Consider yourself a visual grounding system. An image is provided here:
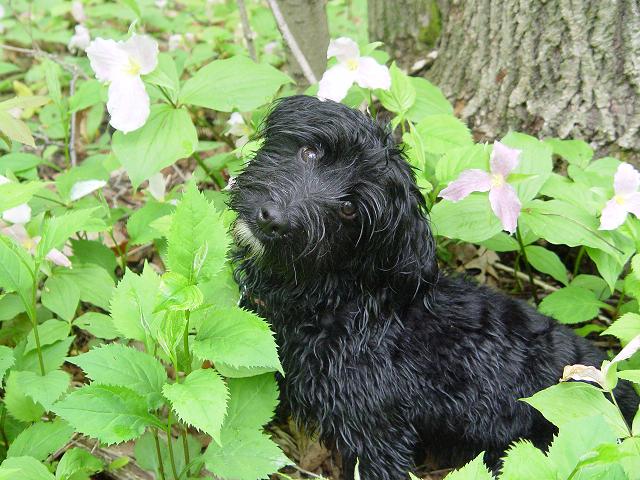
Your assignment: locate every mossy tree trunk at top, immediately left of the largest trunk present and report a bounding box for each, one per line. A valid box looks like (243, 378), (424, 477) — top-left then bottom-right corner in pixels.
(368, 0), (440, 68)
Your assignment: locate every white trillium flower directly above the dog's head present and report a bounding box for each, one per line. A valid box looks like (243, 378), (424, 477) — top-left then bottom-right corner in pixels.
(318, 37), (391, 102)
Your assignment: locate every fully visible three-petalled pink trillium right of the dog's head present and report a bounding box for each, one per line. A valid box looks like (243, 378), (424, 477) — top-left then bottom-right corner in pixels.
(440, 142), (522, 233)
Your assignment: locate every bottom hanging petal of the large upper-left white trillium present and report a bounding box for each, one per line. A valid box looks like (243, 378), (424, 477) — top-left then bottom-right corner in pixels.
(107, 75), (150, 133)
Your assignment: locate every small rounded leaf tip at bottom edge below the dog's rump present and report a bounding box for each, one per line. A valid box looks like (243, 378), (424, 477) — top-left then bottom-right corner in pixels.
(500, 440), (556, 480)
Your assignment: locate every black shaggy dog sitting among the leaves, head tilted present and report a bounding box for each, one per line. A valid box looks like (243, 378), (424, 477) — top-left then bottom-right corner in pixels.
(231, 96), (637, 480)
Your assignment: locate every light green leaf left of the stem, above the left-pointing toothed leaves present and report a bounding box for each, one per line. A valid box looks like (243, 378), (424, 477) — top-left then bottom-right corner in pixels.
(111, 264), (162, 341)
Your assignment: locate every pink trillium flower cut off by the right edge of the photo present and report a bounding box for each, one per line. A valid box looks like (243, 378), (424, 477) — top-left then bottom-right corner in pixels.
(600, 163), (640, 230)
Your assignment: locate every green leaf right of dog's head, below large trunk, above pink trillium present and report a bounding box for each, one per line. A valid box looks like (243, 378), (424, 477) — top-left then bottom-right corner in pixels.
(416, 115), (473, 155)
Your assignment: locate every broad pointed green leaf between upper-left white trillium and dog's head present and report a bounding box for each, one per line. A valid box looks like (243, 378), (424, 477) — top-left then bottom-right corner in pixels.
(180, 56), (291, 112)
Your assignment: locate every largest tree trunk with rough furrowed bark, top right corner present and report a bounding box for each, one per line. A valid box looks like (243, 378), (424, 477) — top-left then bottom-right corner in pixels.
(427, 0), (640, 152)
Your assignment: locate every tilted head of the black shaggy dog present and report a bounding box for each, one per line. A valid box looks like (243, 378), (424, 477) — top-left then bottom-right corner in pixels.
(230, 96), (435, 288)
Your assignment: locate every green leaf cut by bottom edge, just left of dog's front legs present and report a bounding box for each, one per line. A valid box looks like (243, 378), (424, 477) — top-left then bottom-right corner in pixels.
(203, 429), (291, 480)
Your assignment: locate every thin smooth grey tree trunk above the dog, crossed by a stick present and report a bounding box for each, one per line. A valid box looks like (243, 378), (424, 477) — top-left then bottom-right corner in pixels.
(277, 0), (329, 89)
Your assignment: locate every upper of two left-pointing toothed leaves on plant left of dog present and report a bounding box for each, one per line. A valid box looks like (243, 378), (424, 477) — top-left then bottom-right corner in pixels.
(67, 343), (167, 408)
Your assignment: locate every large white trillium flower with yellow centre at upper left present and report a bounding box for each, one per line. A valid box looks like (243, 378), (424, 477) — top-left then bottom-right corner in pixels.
(87, 34), (158, 133)
